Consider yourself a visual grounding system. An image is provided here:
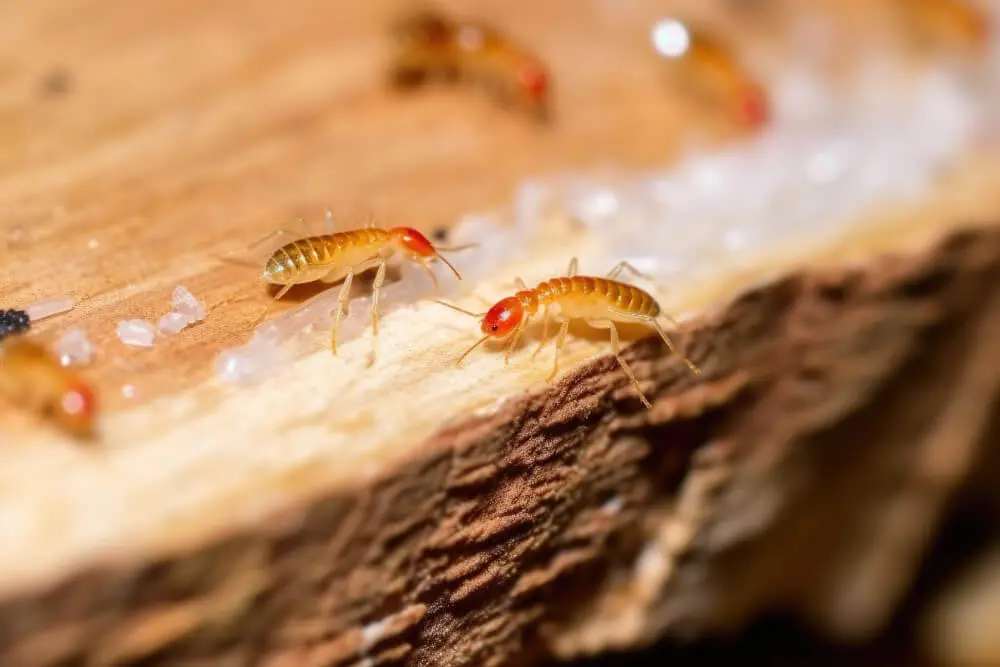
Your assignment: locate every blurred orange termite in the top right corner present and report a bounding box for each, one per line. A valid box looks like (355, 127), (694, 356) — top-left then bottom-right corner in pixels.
(895, 0), (992, 56)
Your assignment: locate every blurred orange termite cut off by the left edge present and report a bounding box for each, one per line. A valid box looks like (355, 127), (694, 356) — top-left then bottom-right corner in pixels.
(0, 335), (97, 439)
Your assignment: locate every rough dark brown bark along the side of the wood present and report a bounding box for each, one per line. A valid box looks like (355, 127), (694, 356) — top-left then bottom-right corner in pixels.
(0, 228), (1000, 667)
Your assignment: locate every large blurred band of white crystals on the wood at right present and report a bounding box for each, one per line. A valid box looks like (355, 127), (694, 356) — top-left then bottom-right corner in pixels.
(568, 59), (984, 278)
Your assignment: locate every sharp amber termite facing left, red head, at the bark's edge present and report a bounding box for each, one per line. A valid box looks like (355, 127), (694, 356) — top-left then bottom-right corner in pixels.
(437, 257), (701, 408)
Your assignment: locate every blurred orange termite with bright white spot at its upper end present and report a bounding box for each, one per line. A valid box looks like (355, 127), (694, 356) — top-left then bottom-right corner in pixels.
(652, 19), (771, 129)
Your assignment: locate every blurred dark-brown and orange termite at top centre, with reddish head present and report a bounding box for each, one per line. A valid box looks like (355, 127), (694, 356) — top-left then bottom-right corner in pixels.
(390, 10), (551, 120)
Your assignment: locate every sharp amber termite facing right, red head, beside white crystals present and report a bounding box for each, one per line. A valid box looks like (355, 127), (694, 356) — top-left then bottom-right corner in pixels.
(245, 214), (475, 354)
